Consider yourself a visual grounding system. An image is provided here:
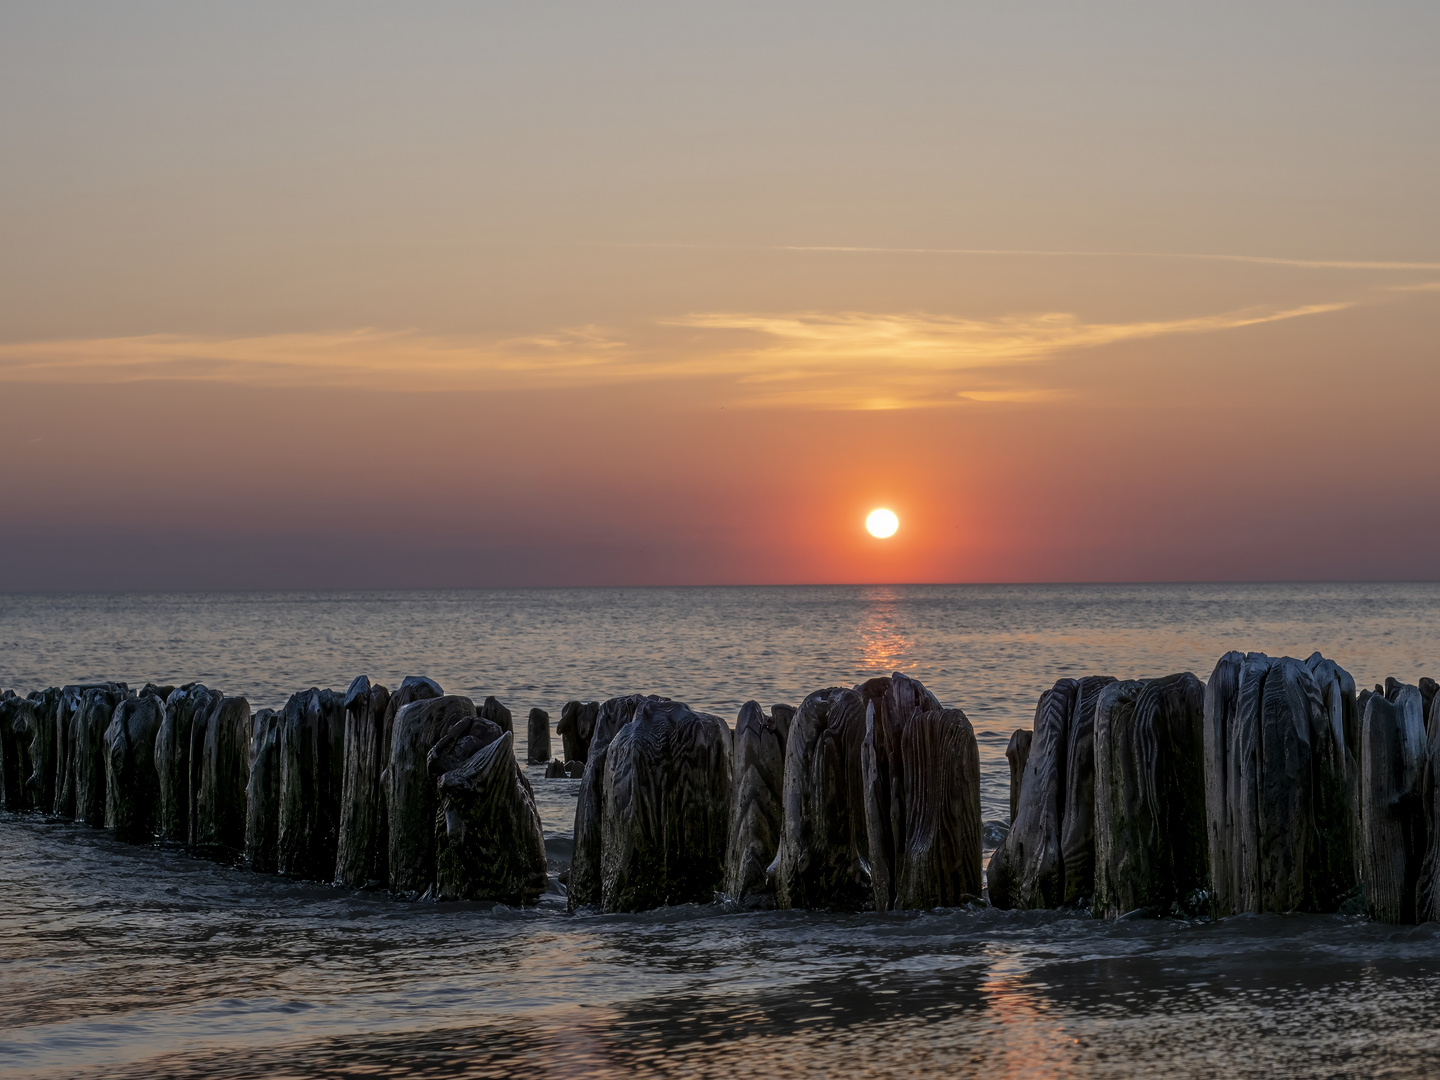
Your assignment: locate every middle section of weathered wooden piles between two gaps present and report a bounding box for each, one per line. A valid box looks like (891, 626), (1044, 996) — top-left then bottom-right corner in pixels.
(555, 674), (984, 912)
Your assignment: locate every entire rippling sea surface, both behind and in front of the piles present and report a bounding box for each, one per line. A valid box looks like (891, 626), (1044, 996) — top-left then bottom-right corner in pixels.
(0, 585), (1440, 1077)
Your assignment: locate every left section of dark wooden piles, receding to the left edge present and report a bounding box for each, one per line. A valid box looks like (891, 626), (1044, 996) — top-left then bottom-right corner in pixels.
(0, 675), (547, 901)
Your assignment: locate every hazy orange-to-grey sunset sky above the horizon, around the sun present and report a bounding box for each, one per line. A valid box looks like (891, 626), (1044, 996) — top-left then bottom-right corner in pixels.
(0, 0), (1440, 590)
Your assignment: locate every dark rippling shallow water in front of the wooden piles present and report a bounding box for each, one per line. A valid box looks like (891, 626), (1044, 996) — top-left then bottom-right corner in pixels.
(11, 815), (1440, 1080)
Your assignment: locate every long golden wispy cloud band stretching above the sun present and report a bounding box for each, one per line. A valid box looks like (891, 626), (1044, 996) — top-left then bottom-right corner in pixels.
(0, 302), (1351, 409)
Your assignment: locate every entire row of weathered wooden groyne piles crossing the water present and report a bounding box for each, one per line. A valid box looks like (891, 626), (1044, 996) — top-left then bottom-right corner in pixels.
(0, 652), (1440, 923)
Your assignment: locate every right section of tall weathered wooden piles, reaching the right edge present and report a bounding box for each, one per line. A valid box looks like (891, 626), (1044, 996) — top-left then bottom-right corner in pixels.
(988, 652), (1440, 923)
